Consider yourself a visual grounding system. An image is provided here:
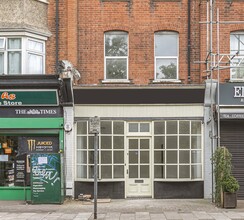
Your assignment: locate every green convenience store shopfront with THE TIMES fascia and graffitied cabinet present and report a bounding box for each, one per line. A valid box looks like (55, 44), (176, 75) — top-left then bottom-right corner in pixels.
(0, 76), (72, 203)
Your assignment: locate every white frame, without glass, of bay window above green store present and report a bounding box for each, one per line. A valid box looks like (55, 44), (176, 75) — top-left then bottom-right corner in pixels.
(0, 32), (47, 75)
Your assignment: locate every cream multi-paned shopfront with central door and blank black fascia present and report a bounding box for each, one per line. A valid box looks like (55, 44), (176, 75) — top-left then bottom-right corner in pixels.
(74, 88), (204, 198)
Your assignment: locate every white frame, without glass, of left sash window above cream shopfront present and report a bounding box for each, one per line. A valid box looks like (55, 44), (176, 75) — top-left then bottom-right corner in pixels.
(103, 31), (129, 83)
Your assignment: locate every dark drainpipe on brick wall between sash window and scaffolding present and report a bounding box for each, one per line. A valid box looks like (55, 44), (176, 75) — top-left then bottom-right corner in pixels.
(187, 0), (191, 82)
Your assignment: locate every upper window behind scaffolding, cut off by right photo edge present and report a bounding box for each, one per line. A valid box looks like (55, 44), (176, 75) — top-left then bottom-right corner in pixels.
(230, 33), (244, 80)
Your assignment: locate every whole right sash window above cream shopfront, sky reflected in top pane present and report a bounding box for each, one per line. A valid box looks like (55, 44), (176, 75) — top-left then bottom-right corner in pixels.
(155, 31), (178, 80)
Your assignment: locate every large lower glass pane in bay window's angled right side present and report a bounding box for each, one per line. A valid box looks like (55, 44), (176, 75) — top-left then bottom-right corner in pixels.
(28, 53), (43, 74)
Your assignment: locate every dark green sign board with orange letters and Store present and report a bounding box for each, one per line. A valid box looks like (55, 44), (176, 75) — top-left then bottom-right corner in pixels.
(0, 89), (59, 107)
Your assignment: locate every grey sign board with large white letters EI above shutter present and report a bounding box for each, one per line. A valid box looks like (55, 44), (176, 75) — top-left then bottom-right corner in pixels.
(219, 83), (244, 106)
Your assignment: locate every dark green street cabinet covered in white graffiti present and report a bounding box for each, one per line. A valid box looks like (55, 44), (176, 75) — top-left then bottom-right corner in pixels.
(31, 153), (61, 204)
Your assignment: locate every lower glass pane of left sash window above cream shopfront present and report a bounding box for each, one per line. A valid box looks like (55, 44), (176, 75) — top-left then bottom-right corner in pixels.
(106, 58), (127, 79)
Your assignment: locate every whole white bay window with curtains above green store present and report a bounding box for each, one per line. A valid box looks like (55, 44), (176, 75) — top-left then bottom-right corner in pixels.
(0, 37), (45, 75)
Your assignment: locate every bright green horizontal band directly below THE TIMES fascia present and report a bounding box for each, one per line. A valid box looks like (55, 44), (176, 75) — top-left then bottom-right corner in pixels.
(0, 118), (64, 129)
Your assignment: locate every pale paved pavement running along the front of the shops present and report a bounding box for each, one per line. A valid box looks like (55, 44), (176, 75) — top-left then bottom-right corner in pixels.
(0, 199), (244, 220)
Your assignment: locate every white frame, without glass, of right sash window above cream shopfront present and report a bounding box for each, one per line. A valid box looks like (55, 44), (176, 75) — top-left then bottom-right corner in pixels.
(154, 31), (180, 82)
